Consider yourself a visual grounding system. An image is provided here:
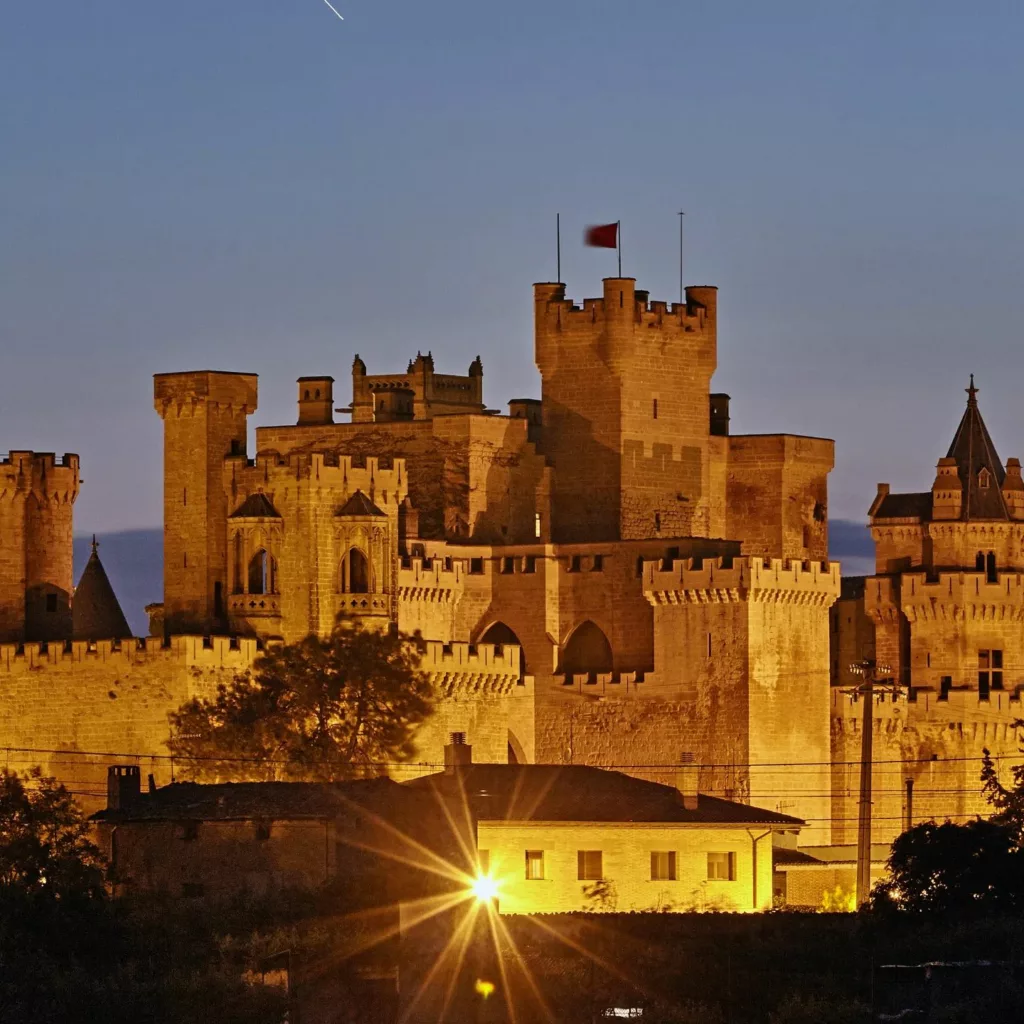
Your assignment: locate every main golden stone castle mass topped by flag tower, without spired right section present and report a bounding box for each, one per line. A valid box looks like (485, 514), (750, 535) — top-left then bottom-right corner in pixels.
(0, 278), (840, 842)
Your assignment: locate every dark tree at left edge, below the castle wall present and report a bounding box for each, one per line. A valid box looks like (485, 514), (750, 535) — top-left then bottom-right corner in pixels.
(0, 768), (103, 899)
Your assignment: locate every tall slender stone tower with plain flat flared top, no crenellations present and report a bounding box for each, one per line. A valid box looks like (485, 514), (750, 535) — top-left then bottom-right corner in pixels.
(154, 371), (257, 634)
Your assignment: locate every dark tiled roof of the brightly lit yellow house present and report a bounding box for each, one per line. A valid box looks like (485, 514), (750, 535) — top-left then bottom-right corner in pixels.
(404, 764), (804, 826)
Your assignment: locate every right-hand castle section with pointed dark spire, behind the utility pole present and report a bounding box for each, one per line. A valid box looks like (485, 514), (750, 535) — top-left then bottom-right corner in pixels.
(830, 377), (1024, 843)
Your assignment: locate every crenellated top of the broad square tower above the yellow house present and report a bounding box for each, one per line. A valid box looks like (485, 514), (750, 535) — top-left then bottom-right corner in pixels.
(643, 557), (840, 606)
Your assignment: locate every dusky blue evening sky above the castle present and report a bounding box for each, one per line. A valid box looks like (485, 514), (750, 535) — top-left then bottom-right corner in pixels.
(0, 6), (1024, 531)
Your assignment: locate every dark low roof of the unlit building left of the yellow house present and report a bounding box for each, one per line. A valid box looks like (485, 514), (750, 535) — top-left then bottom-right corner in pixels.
(92, 778), (410, 821)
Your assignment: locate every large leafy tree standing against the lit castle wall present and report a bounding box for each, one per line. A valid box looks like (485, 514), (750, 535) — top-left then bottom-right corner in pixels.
(168, 624), (431, 781)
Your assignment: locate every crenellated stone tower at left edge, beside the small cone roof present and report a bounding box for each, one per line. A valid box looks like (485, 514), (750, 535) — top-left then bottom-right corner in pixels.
(0, 452), (79, 642)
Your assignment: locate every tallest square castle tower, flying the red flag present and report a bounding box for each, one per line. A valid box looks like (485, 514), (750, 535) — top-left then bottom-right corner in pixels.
(534, 278), (721, 543)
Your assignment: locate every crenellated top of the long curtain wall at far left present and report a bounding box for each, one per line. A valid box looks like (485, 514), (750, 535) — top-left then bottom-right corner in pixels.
(0, 636), (259, 676)
